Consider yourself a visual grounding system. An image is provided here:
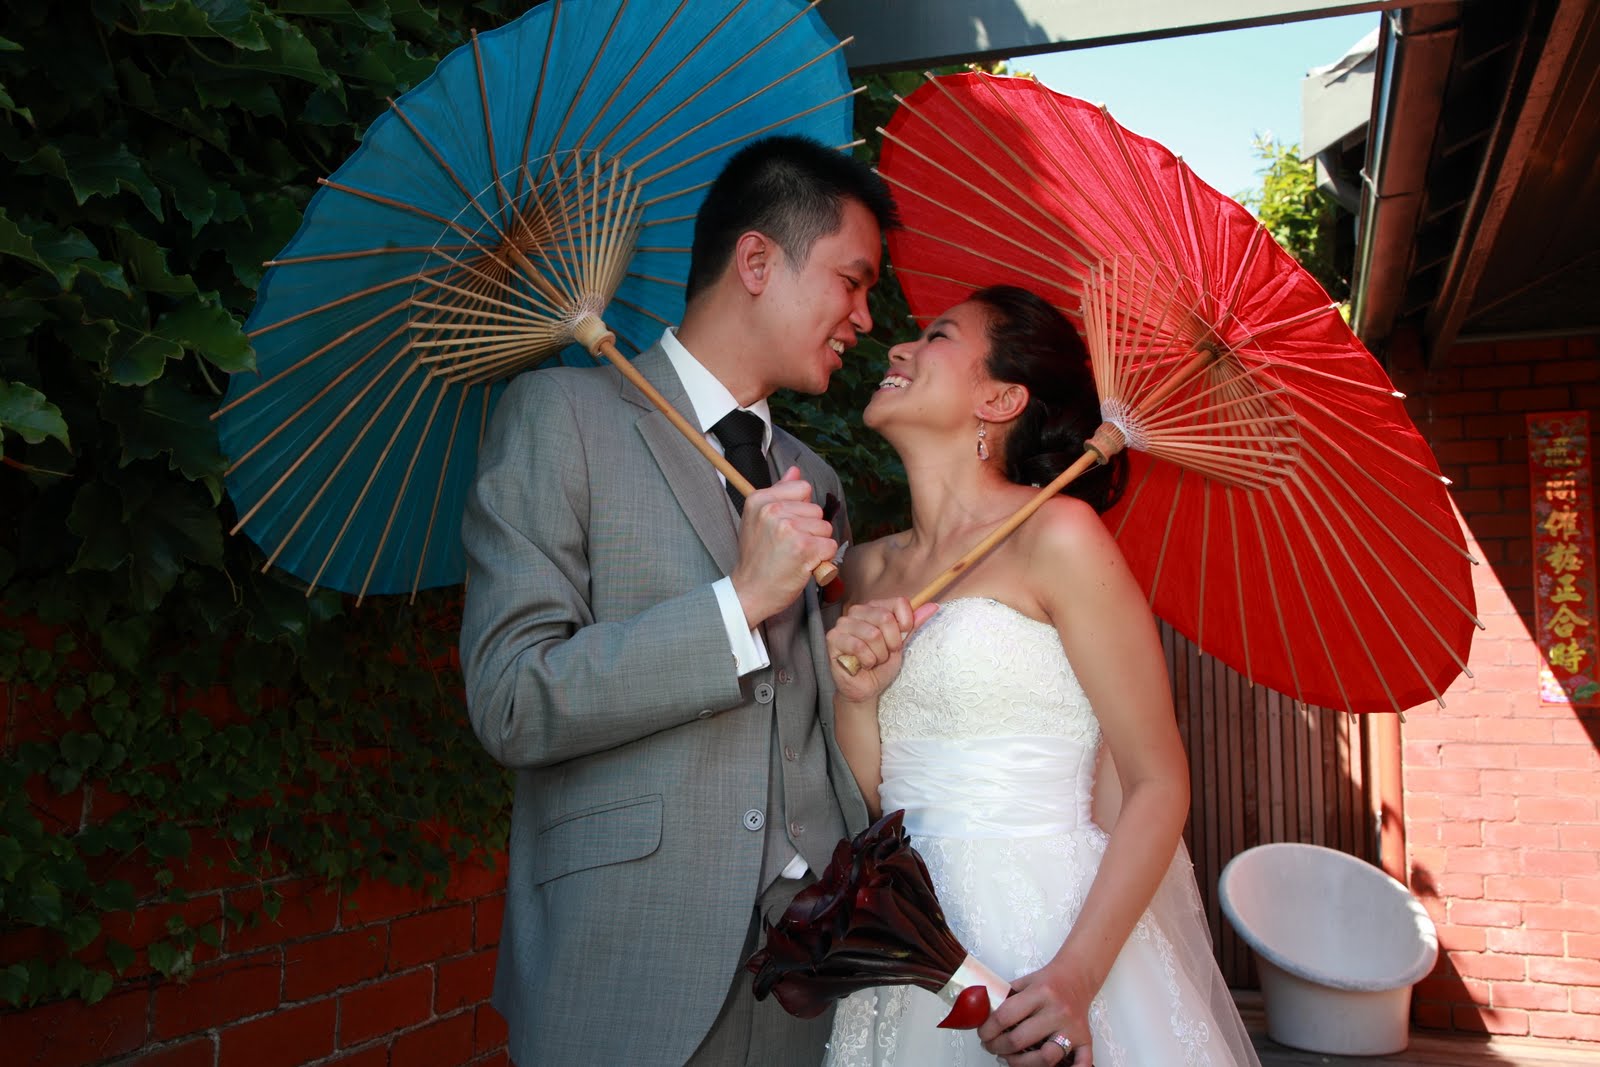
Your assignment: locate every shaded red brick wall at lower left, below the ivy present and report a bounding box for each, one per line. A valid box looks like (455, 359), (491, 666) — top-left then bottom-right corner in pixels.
(0, 864), (506, 1067)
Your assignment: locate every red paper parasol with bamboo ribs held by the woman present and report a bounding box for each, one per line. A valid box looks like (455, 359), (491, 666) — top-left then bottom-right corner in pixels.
(880, 74), (1482, 712)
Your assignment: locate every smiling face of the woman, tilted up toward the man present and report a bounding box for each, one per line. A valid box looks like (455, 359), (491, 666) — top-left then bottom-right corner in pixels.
(862, 301), (989, 432)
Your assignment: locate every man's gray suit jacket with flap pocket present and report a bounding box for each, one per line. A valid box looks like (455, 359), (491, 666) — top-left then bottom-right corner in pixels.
(461, 346), (866, 1067)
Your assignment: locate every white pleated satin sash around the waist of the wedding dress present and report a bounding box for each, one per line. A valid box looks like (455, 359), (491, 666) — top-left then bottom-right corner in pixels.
(878, 736), (1094, 840)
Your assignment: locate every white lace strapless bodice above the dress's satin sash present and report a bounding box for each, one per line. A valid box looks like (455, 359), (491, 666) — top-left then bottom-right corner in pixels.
(878, 597), (1099, 745)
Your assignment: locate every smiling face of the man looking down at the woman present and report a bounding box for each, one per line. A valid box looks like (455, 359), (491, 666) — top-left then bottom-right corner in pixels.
(762, 200), (883, 395)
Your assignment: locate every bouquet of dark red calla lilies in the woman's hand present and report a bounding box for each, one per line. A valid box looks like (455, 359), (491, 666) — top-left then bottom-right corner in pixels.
(746, 811), (1011, 1030)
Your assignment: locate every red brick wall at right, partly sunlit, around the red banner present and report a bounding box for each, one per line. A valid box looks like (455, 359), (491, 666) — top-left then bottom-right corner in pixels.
(1387, 338), (1600, 1041)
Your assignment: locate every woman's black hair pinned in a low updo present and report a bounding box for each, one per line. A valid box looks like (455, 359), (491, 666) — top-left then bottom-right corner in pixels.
(970, 285), (1128, 512)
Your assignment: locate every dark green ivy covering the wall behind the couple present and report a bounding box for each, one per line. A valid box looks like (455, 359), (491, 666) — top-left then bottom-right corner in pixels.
(0, 0), (915, 1006)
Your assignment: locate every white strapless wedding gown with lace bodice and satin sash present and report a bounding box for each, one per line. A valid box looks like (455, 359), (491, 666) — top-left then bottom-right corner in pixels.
(824, 597), (1258, 1067)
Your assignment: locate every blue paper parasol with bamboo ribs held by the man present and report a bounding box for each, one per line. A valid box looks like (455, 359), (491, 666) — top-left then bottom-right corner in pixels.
(216, 0), (851, 595)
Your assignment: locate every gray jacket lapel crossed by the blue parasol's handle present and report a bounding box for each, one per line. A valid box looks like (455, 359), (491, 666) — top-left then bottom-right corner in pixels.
(622, 346), (739, 574)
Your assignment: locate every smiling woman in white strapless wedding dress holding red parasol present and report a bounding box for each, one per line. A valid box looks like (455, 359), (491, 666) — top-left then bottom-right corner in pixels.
(826, 288), (1258, 1067)
